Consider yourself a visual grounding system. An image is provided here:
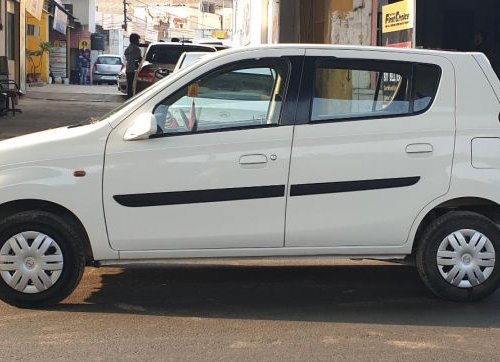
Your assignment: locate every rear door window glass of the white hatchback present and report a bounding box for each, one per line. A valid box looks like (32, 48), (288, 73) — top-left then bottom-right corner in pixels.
(310, 59), (441, 122)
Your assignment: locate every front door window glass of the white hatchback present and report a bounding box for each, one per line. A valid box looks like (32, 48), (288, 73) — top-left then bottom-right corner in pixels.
(154, 59), (289, 135)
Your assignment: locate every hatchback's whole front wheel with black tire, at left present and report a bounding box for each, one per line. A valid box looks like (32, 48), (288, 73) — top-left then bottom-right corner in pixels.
(0, 211), (85, 308)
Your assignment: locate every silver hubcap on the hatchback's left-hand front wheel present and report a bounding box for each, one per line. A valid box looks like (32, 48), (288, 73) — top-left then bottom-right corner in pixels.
(0, 231), (64, 294)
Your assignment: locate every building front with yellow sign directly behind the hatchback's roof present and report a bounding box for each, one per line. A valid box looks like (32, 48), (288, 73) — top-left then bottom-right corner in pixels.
(233, 0), (500, 74)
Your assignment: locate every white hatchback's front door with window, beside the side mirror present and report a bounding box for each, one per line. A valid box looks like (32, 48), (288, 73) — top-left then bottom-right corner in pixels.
(103, 57), (302, 251)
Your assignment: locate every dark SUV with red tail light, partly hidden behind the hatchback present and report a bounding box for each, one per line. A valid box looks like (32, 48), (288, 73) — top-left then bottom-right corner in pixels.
(134, 43), (217, 94)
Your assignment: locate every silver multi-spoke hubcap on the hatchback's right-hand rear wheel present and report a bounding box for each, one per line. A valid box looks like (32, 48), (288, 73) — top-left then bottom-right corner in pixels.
(436, 229), (495, 288)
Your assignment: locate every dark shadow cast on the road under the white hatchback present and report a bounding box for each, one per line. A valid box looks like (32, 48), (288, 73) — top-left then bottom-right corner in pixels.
(55, 265), (500, 327)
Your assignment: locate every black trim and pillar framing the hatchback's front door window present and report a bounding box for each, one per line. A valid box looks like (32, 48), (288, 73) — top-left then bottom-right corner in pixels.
(149, 55), (304, 139)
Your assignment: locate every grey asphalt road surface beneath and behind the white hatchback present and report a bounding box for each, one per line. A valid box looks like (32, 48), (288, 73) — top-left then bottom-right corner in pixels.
(0, 98), (500, 361)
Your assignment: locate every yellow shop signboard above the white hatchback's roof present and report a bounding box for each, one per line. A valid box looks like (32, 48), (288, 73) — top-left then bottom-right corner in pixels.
(382, 0), (415, 48)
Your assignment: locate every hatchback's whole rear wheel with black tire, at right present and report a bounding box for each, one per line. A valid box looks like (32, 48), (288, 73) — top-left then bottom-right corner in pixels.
(416, 211), (500, 302)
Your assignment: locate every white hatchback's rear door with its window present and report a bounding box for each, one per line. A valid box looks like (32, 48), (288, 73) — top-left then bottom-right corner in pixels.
(286, 49), (455, 249)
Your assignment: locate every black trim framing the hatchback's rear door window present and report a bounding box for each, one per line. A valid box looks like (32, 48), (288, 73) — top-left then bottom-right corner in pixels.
(295, 56), (443, 125)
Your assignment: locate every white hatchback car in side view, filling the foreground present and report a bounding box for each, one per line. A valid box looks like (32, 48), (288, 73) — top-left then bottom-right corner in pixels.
(0, 45), (500, 307)
